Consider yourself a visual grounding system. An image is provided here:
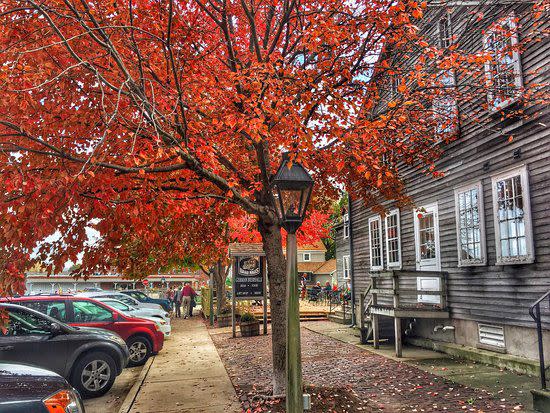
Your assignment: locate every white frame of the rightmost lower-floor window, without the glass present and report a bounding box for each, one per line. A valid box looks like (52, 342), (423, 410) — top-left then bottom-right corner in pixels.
(491, 165), (535, 265)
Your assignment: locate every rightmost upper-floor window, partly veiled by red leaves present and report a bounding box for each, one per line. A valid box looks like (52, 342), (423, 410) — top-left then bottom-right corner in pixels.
(484, 16), (523, 110)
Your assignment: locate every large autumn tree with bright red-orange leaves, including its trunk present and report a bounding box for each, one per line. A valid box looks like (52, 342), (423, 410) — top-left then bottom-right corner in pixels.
(0, 0), (548, 394)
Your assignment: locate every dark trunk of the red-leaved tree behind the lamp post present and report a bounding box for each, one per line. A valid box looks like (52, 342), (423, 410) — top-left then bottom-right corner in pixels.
(258, 218), (286, 395)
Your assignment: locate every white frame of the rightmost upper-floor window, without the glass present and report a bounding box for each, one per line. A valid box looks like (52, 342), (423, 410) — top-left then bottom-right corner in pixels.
(483, 13), (523, 112)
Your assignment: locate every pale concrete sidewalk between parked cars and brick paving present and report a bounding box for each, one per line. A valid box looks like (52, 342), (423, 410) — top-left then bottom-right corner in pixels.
(120, 317), (241, 413)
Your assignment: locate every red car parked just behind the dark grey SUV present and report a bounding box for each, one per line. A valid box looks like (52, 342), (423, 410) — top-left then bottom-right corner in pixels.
(1, 295), (164, 366)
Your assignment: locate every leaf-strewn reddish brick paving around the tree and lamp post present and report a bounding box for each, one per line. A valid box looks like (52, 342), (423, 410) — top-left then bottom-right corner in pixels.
(211, 329), (523, 413)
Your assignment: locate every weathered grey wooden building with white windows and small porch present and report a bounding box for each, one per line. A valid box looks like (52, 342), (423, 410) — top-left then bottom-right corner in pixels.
(336, 2), (550, 359)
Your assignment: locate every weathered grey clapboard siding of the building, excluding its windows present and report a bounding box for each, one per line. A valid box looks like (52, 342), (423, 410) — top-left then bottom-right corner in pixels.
(344, 2), (550, 329)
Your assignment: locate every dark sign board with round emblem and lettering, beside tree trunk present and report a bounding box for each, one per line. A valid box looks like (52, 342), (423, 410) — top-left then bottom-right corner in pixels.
(233, 256), (264, 300)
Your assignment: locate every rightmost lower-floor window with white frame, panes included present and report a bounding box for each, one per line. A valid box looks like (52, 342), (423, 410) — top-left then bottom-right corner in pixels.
(492, 166), (535, 264)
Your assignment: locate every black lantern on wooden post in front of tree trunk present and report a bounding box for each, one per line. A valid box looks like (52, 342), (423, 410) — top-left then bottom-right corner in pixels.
(273, 153), (313, 413)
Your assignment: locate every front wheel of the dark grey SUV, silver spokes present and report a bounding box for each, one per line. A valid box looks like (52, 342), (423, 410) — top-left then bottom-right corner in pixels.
(71, 352), (117, 399)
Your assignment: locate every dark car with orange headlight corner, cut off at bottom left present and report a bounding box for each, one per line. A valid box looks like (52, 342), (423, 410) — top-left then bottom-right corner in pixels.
(0, 362), (84, 413)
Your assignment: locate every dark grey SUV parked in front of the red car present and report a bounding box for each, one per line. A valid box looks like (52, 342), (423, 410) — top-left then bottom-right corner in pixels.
(0, 303), (128, 397)
